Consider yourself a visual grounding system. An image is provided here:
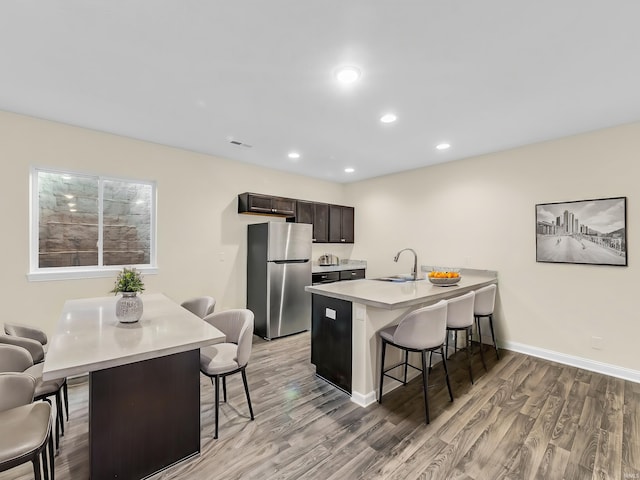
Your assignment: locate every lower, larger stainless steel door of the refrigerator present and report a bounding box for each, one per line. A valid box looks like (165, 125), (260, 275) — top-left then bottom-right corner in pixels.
(264, 261), (311, 338)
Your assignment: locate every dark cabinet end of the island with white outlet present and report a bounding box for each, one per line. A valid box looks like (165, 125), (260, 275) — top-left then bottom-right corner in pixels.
(311, 295), (352, 395)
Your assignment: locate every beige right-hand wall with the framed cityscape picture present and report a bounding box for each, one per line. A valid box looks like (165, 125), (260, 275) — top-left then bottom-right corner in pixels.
(348, 123), (640, 378)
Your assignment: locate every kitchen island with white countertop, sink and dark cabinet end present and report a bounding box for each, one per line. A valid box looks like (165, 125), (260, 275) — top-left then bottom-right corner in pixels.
(305, 267), (497, 407)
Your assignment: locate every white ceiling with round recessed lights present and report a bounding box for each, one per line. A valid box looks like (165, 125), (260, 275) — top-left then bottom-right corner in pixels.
(0, 0), (640, 182)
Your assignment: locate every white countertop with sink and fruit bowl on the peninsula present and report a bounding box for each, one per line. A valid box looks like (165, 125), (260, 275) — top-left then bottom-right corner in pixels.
(305, 270), (498, 310)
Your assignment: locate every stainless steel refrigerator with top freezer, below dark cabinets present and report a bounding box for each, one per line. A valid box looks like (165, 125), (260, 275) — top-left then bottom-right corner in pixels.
(247, 222), (312, 339)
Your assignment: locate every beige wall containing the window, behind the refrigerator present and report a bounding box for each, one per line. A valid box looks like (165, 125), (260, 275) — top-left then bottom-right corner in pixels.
(0, 112), (351, 333)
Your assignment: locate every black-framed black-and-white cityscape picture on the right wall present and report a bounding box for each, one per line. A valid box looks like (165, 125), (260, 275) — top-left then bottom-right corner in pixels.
(536, 197), (627, 266)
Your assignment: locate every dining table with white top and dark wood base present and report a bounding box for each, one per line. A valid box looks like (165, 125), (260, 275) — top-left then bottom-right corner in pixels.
(42, 294), (225, 480)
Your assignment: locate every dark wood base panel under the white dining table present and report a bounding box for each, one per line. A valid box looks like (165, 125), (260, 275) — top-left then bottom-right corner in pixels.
(89, 350), (200, 480)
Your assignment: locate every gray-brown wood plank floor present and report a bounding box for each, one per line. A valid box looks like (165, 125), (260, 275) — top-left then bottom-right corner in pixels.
(0, 333), (640, 480)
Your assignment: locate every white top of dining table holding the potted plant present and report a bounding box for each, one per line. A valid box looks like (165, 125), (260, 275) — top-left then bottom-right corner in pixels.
(42, 293), (225, 380)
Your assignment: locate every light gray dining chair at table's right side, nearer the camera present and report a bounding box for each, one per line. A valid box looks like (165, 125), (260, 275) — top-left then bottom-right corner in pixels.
(200, 309), (254, 438)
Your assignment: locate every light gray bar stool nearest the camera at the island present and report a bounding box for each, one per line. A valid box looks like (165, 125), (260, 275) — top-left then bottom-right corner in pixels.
(378, 300), (453, 424)
